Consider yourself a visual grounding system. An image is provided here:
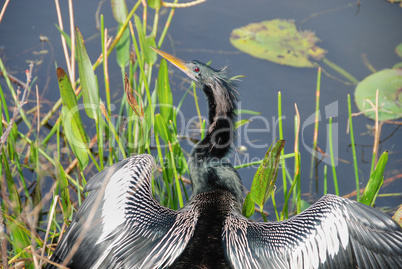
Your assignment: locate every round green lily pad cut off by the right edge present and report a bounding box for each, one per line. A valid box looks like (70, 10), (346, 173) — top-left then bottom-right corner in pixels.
(355, 69), (402, 121)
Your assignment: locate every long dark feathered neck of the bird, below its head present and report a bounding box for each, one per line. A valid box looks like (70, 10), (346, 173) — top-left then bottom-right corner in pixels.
(189, 77), (243, 203)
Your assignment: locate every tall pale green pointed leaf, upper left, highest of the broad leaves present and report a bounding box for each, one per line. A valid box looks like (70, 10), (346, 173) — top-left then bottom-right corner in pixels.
(75, 27), (99, 121)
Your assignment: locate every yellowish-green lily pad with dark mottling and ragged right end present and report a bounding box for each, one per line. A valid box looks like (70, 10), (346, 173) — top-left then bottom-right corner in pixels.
(230, 19), (326, 67)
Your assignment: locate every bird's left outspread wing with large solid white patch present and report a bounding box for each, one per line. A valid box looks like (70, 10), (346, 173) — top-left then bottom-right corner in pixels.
(46, 154), (198, 268)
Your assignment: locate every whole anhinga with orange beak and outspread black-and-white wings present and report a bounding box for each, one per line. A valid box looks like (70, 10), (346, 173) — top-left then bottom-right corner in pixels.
(47, 49), (402, 269)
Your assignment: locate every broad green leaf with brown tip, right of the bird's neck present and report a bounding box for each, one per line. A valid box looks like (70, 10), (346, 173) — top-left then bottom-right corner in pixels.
(250, 140), (285, 208)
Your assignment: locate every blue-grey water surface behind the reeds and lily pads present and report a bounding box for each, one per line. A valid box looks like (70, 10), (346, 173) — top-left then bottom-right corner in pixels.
(0, 0), (402, 215)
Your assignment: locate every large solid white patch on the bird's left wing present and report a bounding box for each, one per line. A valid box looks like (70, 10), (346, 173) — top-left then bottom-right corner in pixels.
(96, 164), (130, 244)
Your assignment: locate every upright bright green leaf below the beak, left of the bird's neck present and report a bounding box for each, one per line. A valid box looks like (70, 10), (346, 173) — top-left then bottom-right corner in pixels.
(157, 59), (173, 123)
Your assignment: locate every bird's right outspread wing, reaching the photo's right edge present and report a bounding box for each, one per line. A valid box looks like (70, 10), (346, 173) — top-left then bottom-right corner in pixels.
(222, 195), (402, 269)
